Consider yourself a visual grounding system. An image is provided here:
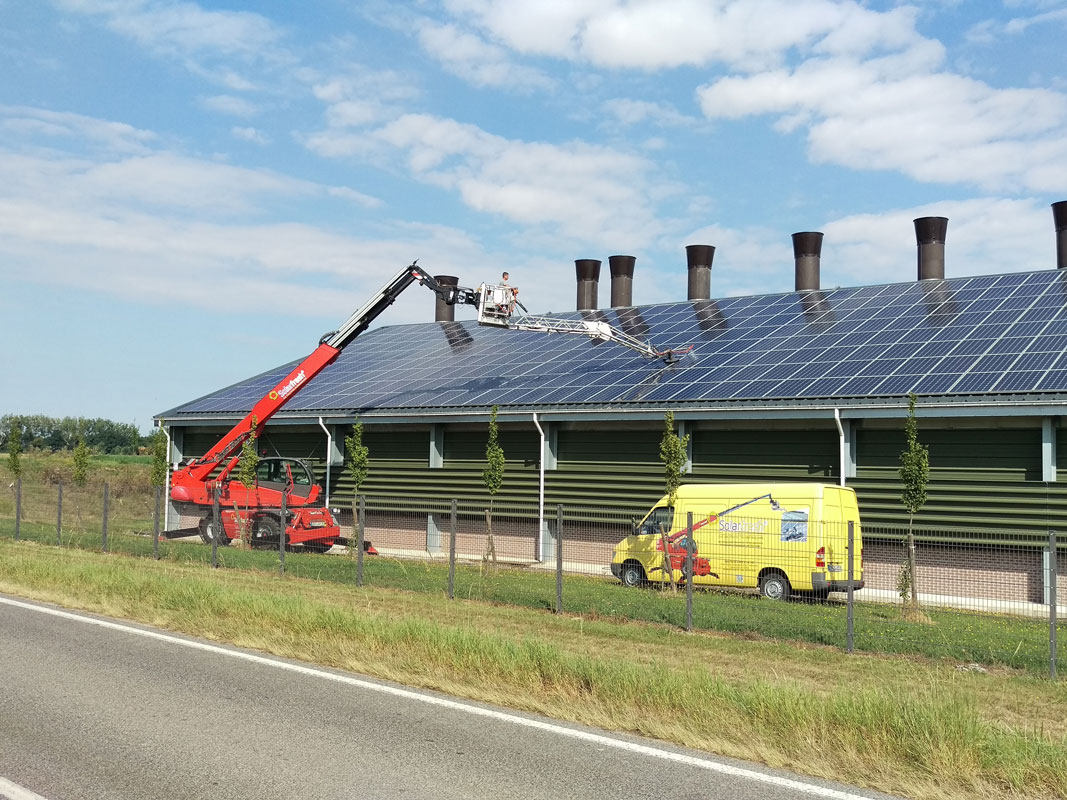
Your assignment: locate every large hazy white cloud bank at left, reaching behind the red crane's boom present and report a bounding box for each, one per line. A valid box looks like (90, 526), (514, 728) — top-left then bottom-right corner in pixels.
(0, 109), (550, 324)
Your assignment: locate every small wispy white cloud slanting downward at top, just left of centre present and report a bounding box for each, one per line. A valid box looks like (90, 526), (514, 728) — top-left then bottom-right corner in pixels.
(416, 19), (553, 91)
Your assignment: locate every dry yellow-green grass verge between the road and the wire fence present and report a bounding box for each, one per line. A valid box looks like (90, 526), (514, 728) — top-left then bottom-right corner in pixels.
(0, 539), (1067, 799)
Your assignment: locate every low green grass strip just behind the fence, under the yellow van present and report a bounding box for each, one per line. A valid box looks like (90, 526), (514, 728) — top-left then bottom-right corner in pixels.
(0, 518), (1067, 675)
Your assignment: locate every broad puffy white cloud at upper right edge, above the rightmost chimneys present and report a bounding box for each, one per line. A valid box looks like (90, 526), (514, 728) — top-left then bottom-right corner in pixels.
(698, 54), (1067, 192)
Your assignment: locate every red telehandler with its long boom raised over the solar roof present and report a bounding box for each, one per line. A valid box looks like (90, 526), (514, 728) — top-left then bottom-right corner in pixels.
(168, 263), (480, 551)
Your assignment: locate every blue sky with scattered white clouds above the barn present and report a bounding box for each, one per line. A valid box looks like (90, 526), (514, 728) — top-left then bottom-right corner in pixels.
(0, 0), (1067, 432)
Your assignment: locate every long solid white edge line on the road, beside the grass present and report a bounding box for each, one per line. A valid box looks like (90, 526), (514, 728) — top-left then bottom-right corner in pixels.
(0, 597), (870, 800)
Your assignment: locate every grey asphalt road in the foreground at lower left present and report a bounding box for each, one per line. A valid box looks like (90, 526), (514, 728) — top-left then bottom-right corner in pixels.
(0, 596), (900, 800)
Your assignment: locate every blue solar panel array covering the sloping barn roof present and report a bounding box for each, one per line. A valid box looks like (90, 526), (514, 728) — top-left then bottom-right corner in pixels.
(163, 271), (1067, 416)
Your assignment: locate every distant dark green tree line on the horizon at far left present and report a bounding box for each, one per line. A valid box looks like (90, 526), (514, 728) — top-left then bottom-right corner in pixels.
(0, 414), (152, 455)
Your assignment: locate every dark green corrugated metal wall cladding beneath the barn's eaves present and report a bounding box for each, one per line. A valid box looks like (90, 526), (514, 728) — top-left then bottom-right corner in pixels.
(177, 426), (1067, 539)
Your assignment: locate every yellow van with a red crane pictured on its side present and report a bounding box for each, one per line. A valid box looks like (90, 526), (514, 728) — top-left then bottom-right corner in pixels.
(611, 483), (863, 599)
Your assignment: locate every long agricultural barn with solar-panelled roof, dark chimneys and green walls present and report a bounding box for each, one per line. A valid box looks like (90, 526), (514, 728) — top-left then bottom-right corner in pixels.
(157, 202), (1067, 602)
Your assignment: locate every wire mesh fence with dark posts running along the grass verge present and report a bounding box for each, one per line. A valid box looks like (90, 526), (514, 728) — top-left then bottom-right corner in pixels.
(0, 480), (1067, 676)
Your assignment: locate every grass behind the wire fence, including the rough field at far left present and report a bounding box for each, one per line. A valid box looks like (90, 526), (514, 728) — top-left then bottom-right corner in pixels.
(0, 454), (1067, 675)
